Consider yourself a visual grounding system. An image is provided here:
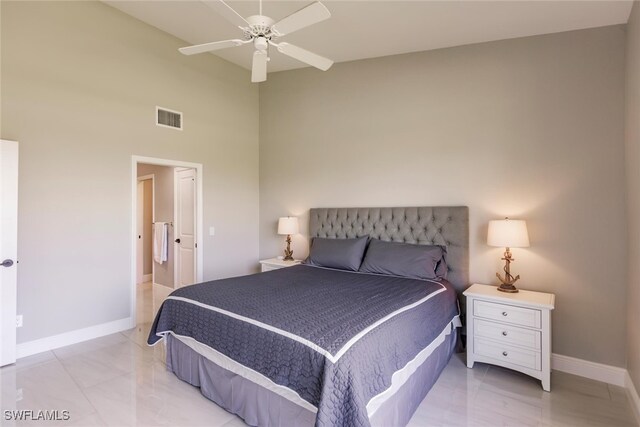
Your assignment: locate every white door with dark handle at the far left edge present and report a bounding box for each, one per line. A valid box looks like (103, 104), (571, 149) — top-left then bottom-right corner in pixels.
(0, 141), (18, 366)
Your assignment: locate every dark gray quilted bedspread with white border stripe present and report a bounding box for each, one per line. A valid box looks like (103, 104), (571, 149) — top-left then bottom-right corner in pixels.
(148, 265), (458, 426)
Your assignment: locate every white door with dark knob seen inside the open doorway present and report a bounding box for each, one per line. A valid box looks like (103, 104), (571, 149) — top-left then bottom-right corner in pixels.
(174, 169), (197, 288)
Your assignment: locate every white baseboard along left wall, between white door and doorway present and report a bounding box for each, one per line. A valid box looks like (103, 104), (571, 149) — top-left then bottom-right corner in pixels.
(16, 317), (135, 359)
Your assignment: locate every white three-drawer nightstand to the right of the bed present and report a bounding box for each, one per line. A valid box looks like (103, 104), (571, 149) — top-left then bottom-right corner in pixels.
(464, 284), (555, 391)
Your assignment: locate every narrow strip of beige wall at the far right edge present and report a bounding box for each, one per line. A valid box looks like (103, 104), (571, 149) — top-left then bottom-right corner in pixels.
(626, 1), (640, 390)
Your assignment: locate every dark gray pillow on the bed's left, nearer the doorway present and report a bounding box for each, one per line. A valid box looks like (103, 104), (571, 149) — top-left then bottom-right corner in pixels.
(306, 236), (369, 271)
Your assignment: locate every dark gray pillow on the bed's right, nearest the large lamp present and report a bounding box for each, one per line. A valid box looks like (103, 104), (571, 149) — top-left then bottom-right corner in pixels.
(360, 239), (447, 279)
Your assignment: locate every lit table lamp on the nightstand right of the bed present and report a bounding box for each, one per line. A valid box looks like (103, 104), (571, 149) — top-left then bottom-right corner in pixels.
(487, 218), (529, 293)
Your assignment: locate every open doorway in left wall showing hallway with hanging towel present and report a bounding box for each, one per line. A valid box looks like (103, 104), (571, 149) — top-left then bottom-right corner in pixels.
(131, 156), (203, 334)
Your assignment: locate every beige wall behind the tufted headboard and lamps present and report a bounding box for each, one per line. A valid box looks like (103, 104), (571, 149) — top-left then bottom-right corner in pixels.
(260, 26), (627, 366)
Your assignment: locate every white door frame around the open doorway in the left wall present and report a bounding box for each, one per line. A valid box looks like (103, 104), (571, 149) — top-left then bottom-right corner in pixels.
(129, 155), (204, 328)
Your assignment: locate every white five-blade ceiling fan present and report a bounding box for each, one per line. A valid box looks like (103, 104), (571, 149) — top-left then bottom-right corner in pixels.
(178, 0), (333, 83)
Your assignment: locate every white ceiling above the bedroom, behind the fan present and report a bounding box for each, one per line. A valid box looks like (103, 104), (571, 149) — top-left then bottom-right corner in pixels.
(105, 0), (633, 72)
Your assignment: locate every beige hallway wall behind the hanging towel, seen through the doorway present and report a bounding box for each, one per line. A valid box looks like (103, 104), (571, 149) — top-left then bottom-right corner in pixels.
(138, 163), (175, 288)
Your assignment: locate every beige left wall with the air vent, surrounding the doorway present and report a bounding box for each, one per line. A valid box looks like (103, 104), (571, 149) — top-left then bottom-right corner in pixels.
(0, 1), (259, 343)
